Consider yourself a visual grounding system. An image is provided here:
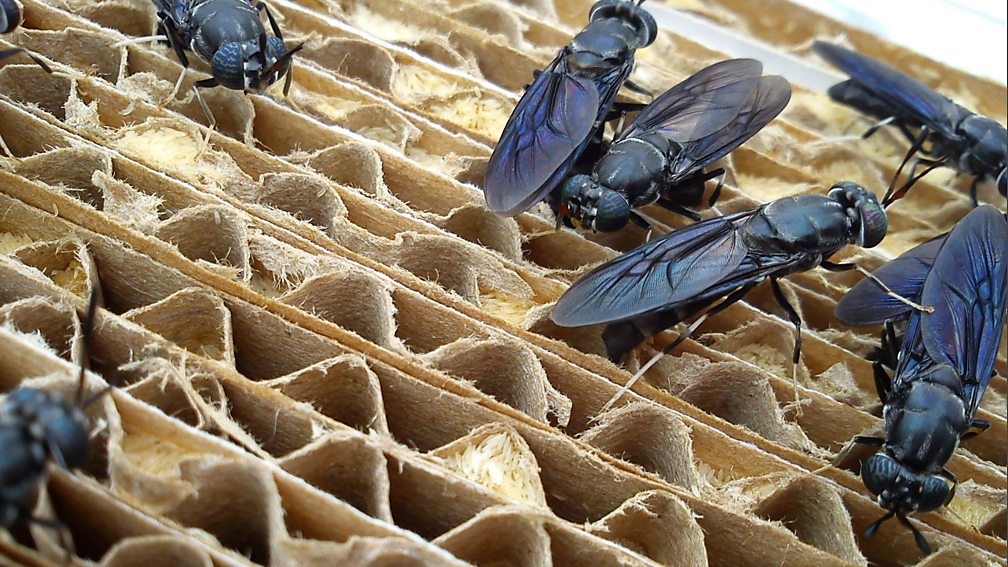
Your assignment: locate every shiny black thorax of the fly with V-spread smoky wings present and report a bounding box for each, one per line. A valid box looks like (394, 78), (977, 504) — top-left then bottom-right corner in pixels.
(592, 138), (668, 207)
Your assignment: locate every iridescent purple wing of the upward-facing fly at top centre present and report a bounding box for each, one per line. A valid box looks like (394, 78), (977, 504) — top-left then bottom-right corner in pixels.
(483, 58), (596, 216)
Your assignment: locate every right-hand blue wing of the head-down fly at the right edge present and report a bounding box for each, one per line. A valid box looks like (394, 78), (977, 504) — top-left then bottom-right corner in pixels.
(920, 205), (1008, 418)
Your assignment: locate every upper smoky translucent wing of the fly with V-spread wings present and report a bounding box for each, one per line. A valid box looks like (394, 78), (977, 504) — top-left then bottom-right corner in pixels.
(614, 60), (763, 143)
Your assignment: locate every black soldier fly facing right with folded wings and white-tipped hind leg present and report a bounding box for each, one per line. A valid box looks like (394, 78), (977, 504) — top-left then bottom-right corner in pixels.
(550, 182), (888, 407)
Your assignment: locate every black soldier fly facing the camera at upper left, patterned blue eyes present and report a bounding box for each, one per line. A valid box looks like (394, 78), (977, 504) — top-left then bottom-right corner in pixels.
(153, 0), (302, 125)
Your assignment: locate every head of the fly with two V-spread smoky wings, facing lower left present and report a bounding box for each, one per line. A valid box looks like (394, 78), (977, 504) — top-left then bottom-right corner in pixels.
(560, 175), (630, 232)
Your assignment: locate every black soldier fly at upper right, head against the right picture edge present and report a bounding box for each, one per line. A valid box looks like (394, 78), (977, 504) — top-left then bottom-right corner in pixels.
(812, 41), (1008, 206)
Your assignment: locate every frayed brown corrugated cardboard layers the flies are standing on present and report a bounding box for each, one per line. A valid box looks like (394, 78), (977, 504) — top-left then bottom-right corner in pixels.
(0, 0), (1008, 565)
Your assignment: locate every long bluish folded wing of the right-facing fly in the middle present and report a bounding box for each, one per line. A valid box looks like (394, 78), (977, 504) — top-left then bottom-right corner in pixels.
(550, 211), (753, 327)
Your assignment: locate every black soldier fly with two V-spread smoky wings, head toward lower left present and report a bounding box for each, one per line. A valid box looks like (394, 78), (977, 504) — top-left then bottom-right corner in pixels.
(558, 60), (791, 231)
